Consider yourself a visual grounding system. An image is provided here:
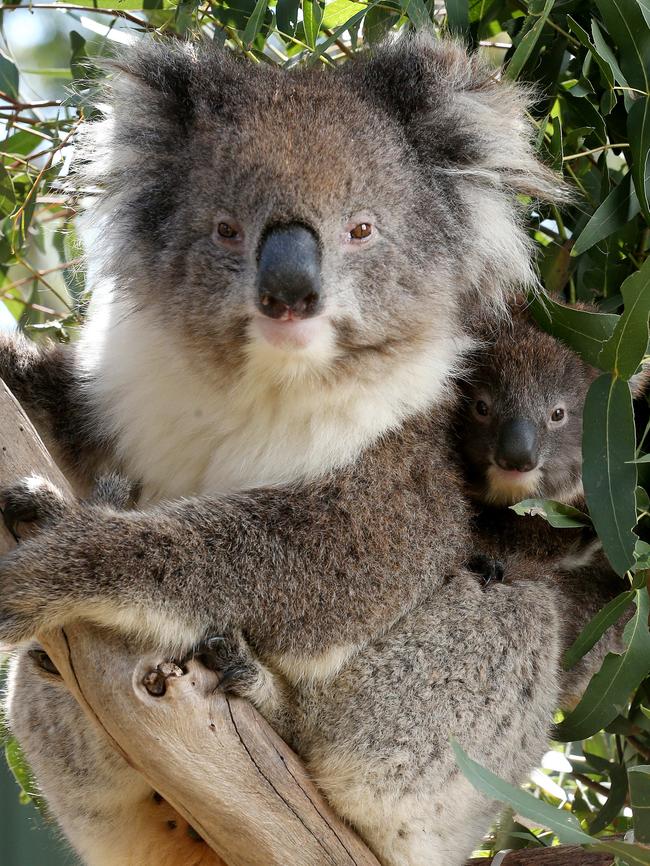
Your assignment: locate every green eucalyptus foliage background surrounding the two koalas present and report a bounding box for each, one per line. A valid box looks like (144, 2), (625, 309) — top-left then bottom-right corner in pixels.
(0, 0), (650, 866)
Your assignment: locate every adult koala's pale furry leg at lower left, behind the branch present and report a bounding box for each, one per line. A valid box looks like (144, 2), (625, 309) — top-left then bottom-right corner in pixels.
(7, 649), (223, 866)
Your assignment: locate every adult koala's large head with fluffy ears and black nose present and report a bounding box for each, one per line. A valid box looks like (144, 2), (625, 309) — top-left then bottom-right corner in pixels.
(77, 36), (559, 390)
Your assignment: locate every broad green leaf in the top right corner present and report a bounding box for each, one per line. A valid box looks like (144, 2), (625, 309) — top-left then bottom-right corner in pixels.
(596, 0), (650, 93)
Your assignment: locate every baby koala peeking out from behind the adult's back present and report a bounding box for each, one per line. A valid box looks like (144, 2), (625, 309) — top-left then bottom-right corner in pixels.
(451, 297), (624, 707)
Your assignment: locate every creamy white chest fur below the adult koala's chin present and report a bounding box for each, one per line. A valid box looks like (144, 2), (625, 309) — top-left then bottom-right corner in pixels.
(79, 288), (458, 502)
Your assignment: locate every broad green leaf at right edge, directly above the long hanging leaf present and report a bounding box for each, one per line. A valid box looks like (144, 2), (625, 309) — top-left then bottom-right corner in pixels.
(598, 259), (650, 381)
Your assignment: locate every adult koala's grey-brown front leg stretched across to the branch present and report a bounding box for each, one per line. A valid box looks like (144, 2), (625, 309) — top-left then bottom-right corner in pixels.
(0, 466), (426, 655)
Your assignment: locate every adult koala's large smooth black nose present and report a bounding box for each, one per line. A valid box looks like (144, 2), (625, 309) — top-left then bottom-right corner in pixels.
(257, 223), (322, 319)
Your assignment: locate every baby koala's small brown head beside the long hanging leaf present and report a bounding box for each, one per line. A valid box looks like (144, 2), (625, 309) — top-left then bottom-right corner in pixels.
(456, 306), (597, 506)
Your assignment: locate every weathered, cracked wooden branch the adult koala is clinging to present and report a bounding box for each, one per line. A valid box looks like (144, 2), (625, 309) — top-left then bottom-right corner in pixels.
(0, 381), (613, 866)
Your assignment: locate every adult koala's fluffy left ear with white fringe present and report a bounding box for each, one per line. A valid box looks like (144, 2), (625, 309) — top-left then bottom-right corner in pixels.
(75, 40), (234, 248)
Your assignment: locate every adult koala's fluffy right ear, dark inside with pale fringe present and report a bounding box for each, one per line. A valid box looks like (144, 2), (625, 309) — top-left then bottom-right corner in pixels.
(350, 33), (564, 200)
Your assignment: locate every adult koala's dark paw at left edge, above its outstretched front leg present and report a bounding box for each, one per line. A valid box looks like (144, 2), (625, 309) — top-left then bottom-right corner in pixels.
(0, 475), (70, 540)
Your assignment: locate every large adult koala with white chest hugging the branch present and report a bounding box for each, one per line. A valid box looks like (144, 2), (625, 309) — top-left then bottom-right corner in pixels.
(0, 36), (561, 866)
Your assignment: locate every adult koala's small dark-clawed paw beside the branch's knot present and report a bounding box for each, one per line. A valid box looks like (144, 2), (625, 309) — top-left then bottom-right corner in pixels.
(192, 631), (273, 705)
